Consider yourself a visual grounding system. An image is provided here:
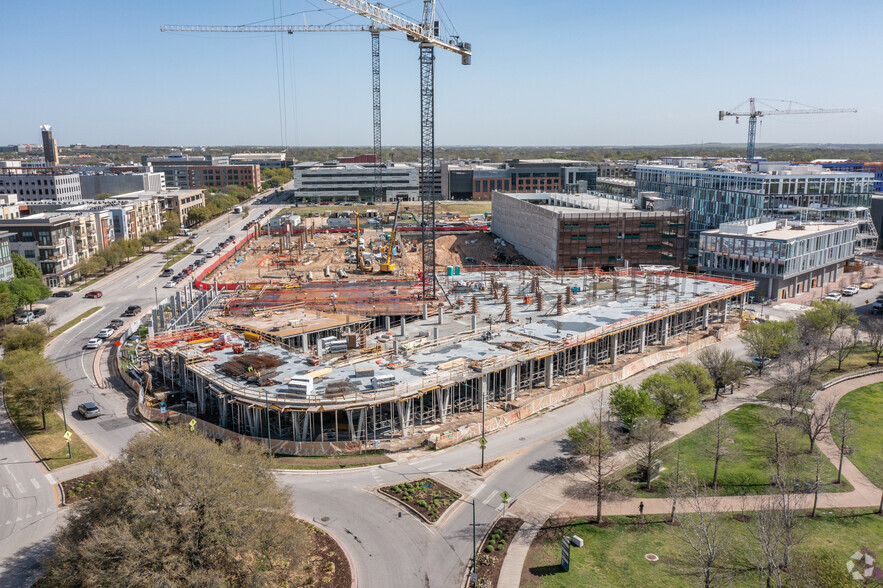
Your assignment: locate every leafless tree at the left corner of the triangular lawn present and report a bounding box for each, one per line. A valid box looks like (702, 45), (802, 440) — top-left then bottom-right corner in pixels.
(567, 420), (618, 525)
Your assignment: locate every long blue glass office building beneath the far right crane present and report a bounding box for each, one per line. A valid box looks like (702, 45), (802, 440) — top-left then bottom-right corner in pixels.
(635, 158), (874, 232)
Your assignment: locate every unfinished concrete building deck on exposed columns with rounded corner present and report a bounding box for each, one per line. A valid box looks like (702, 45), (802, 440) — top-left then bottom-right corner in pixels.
(142, 266), (754, 448)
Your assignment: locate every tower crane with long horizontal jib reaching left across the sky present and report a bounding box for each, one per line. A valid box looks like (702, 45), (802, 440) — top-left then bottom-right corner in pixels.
(159, 24), (395, 204)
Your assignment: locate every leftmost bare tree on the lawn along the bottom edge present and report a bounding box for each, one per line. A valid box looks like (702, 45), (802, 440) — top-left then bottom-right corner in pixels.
(677, 479), (731, 588)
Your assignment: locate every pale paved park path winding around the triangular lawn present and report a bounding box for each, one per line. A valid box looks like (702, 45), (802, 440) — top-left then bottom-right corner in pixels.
(498, 374), (883, 586)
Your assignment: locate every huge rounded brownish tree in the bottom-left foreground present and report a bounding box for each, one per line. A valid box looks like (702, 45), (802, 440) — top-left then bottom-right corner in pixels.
(43, 427), (310, 588)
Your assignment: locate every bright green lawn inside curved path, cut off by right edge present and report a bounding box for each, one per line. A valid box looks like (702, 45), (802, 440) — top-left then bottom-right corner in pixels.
(837, 382), (883, 487)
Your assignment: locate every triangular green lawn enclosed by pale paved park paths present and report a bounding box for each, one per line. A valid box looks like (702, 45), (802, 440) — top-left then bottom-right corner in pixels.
(635, 404), (852, 497)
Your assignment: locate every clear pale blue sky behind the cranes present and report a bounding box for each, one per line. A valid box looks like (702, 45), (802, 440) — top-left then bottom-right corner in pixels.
(0, 0), (883, 146)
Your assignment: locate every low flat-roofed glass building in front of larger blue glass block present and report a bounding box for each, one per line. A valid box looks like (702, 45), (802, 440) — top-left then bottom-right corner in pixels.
(699, 218), (858, 300)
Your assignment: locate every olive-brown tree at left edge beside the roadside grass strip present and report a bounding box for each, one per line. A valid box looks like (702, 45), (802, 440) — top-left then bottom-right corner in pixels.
(0, 349), (70, 429)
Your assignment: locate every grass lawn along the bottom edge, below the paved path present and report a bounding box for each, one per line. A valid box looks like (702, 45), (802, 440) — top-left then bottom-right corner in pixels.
(521, 511), (883, 588)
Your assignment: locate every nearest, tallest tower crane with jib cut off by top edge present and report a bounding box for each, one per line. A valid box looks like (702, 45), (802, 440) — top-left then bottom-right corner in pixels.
(325, 0), (472, 299)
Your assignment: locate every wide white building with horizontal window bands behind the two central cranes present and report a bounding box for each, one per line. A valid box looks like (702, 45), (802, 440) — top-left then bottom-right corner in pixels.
(294, 161), (420, 202)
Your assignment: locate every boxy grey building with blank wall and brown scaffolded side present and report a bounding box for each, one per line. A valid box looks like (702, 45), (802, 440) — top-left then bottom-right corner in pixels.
(491, 192), (689, 270)
